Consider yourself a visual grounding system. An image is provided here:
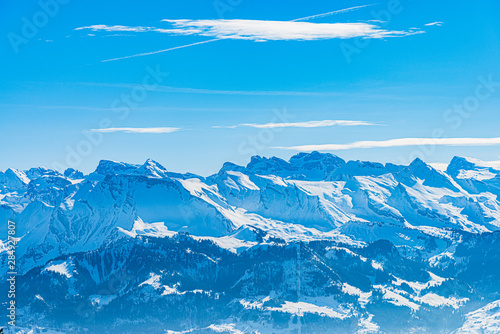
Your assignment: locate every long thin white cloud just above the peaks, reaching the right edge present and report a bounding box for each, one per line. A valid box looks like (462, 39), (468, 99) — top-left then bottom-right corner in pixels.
(273, 137), (500, 151)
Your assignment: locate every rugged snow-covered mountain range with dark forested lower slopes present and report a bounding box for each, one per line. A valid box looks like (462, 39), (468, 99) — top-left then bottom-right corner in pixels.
(0, 152), (500, 333)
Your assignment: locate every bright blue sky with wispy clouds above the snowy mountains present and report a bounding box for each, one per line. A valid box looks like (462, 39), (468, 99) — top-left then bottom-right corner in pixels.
(0, 0), (500, 175)
